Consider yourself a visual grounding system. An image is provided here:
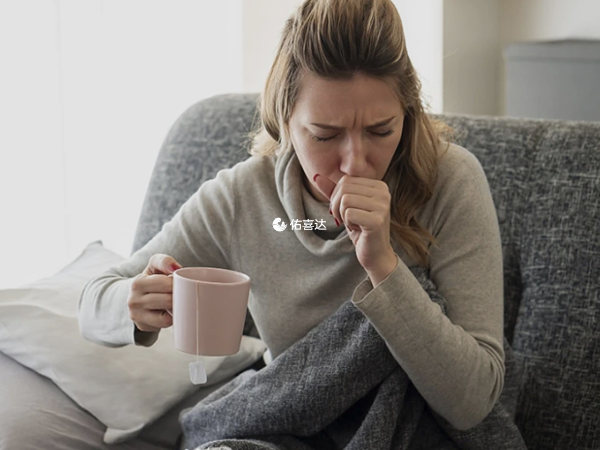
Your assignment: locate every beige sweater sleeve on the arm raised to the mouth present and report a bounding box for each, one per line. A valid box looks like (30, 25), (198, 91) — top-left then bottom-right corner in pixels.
(352, 155), (505, 430)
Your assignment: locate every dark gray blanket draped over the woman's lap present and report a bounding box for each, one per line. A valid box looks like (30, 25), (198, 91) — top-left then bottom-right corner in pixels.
(179, 267), (526, 450)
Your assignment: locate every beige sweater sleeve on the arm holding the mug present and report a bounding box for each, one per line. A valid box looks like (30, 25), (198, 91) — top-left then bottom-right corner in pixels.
(78, 166), (236, 347)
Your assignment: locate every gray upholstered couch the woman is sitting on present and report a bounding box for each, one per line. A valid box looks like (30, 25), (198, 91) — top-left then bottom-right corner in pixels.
(0, 94), (600, 450)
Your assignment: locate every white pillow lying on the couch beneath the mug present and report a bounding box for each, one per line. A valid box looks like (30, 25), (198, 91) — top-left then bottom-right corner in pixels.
(0, 241), (266, 444)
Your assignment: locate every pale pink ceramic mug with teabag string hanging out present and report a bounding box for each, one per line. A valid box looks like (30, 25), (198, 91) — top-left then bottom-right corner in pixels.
(172, 267), (250, 356)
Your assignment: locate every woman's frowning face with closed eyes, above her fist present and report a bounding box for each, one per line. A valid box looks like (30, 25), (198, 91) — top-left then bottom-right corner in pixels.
(289, 72), (404, 202)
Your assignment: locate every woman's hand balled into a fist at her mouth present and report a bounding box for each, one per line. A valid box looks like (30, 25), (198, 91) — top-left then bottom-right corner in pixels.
(314, 174), (397, 273)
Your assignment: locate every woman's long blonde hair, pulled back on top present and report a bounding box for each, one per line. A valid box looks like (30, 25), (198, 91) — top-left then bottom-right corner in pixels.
(248, 0), (453, 267)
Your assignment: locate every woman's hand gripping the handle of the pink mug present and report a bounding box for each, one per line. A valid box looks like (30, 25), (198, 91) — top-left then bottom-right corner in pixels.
(127, 253), (181, 331)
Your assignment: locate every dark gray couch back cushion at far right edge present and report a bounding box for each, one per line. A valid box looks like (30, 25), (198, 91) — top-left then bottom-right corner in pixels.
(513, 123), (600, 449)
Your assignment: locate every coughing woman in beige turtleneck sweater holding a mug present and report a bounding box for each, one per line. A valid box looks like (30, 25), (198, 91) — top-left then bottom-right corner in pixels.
(80, 0), (505, 438)
